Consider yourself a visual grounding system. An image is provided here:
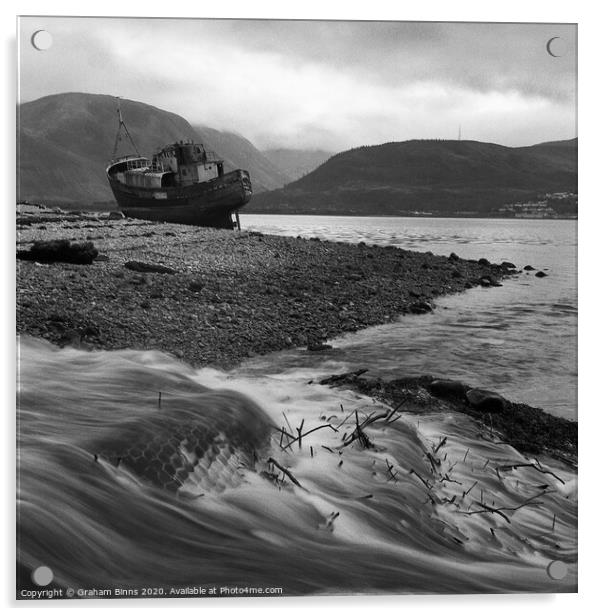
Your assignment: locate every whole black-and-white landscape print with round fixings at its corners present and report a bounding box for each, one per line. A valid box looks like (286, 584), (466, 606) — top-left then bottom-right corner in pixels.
(15, 13), (579, 609)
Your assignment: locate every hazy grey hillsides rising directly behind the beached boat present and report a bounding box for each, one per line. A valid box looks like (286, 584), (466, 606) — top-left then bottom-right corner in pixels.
(17, 93), (287, 207)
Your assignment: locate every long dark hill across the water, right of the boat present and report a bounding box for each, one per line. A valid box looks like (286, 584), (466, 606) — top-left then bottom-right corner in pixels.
(248, 139), (577, 215)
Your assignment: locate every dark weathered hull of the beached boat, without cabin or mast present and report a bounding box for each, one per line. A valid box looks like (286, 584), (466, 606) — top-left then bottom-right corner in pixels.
(107, 170), (253, 229)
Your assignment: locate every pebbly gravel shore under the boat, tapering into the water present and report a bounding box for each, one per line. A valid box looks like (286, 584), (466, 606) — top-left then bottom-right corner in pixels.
(17, 212), (513, 368)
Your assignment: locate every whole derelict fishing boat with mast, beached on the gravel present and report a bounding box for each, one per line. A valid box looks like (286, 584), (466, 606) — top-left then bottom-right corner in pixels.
(106, 103), (253, 229)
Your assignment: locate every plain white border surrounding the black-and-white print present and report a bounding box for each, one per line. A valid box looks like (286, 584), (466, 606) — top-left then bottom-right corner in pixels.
(0, 0), (602, 616)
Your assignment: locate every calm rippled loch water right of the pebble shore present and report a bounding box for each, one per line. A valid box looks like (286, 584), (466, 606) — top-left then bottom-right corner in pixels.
(242, 215), (577, 419)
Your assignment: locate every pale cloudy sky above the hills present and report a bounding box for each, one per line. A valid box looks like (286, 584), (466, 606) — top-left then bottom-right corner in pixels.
(18, 17), (577, 151)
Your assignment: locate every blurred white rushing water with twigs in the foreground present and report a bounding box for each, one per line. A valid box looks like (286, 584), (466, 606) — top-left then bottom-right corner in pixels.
(17, 337), (577, 595)
